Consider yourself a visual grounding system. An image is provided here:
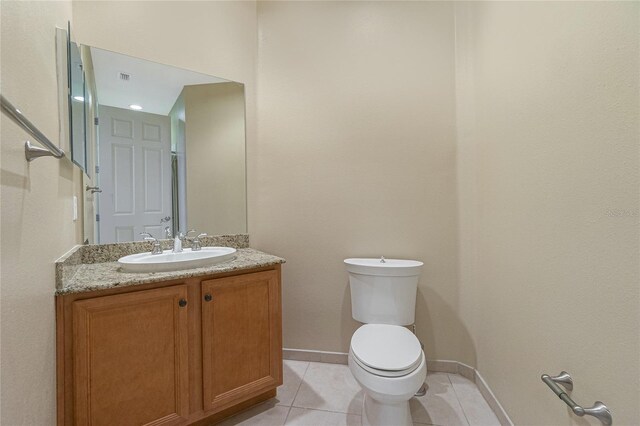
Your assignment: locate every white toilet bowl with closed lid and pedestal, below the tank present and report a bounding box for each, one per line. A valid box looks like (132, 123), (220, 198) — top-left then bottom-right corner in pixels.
(349, 324), (427, 426)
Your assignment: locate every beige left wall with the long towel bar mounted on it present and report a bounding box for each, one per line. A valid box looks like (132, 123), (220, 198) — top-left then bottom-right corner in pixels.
(0, 1), (82, 425)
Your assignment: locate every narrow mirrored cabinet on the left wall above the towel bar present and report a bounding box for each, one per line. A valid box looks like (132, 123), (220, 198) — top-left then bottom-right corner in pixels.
(67, 24), (89, 173)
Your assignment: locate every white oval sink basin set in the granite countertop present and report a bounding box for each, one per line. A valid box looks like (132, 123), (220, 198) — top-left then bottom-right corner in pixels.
(118, 247), (236, 272)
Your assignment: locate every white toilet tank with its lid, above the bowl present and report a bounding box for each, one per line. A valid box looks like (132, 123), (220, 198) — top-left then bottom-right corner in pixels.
(344, 258), (423, 325)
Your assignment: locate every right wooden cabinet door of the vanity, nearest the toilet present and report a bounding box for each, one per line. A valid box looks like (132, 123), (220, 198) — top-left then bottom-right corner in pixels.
(202, 271), (282, 411)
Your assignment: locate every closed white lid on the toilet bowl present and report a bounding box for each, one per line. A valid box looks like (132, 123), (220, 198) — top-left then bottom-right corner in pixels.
(351, 324), (422, 372)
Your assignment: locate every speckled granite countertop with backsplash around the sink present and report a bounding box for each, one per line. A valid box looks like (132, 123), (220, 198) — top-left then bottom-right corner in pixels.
(56, 234), (285, 295)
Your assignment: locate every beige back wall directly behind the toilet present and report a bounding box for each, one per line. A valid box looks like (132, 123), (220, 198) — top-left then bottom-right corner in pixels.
(255, 2), (469, 359)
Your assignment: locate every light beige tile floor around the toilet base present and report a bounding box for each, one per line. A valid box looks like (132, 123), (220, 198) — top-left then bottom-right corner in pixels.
(222, 360), (500, 426)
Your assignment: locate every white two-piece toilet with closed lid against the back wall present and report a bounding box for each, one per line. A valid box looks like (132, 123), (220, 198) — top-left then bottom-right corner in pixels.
(344, 258), (427, 426)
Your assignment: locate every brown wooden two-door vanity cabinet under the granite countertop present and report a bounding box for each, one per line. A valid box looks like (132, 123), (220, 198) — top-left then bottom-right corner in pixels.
(56, 265), (282, 426)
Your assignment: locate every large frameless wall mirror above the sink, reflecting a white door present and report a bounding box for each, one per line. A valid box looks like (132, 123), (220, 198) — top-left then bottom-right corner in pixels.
(80, 46), (247, 244)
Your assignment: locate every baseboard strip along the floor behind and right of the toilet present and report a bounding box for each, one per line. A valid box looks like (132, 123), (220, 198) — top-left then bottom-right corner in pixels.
(282, 348), (513, 426)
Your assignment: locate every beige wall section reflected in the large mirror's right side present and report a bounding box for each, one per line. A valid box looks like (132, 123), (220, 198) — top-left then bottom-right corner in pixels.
(182, 83), (247, 235)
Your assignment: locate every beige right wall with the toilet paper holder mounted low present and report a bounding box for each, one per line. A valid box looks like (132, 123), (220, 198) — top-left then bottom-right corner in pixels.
(456, 2), (640, 425)
